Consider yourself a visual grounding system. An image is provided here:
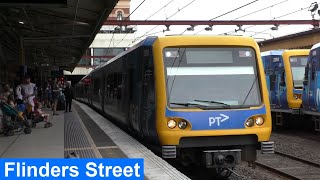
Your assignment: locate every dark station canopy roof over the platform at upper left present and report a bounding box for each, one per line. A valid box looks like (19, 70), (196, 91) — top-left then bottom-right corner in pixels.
(0, 0), (118, 71)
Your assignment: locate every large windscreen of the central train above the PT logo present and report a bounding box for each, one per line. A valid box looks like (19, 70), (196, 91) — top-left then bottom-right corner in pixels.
(163, 47), (261, 109)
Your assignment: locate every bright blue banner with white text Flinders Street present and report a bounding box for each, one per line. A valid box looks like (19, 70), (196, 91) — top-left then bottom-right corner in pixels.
(0, 158), (144, 179)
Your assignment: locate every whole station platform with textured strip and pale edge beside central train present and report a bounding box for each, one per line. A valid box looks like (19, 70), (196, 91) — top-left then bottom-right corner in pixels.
(0, 101), (189, 180)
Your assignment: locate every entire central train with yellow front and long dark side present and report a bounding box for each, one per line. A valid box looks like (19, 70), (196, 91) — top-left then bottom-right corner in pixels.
(75, 36), (274, 174)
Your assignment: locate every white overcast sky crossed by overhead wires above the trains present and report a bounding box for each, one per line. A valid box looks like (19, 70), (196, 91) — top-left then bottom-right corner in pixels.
(126, 0), (320, 44)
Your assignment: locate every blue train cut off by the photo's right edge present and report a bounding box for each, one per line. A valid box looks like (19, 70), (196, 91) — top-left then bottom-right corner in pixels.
(302, 43), (320, 132)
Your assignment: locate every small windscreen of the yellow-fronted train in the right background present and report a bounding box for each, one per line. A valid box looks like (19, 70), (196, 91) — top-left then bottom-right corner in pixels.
(290, 56), (308, 88)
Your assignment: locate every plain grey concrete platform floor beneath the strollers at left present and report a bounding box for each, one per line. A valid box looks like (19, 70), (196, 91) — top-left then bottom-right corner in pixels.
(0, 110), (64, 158)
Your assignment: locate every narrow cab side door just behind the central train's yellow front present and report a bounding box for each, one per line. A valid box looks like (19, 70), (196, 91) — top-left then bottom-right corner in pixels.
(140, 47), (155, 139)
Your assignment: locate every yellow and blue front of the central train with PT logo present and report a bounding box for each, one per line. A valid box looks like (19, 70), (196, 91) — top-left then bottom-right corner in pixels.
(153, 37), (273, 168)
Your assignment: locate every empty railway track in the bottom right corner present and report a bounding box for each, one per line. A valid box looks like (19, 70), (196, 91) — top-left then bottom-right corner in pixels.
(256, 151), (320, 180)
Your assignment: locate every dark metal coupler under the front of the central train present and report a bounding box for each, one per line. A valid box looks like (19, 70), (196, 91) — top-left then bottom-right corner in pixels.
(203, 149), (241, 168)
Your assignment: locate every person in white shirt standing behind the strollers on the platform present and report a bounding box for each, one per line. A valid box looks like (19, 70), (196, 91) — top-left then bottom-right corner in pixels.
(20, 76), (37, 111)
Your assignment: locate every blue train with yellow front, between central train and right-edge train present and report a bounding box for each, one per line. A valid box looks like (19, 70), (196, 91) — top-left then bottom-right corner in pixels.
(261, 49), (310, 127)
